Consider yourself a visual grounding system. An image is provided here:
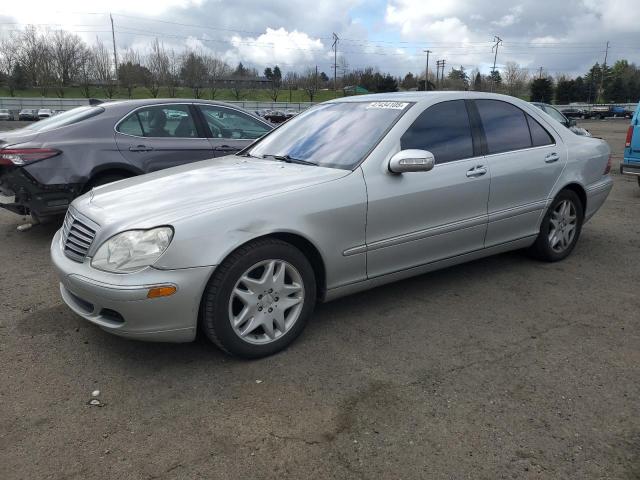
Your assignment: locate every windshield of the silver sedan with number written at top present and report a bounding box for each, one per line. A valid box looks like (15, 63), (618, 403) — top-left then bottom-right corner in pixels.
(246, 102), (411, 170)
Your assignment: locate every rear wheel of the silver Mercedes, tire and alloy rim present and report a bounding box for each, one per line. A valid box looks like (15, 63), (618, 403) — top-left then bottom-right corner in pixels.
(529, 190), (584, 262)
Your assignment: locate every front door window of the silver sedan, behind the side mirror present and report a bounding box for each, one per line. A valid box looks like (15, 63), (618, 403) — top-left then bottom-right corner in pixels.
(400, 100), (473, 163)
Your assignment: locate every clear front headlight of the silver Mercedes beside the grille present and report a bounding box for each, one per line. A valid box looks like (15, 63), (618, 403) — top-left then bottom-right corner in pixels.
(91, 227), (173, 273)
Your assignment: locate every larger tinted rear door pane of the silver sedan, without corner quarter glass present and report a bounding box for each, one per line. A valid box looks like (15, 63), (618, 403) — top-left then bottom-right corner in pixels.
(475, 100), (531, 153)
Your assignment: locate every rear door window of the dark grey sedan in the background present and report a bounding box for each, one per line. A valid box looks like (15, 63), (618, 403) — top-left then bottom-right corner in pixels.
(117, 105), (198, 138)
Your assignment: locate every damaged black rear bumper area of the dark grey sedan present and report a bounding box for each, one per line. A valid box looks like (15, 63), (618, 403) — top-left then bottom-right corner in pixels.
(0, 167), (82, 217)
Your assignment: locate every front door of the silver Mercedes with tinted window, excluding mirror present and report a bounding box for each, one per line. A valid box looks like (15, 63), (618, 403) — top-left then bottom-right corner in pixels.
(365, 100), (491, 278)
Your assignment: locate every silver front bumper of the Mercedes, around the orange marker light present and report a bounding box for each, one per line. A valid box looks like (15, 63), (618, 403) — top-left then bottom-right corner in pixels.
(51, 231), (214, 342)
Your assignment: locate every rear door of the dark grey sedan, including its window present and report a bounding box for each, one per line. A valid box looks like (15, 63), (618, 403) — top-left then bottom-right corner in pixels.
(115, 103), (213, 172)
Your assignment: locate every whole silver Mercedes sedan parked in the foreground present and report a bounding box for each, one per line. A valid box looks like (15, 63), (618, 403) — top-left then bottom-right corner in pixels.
(51, 92), (612, 358)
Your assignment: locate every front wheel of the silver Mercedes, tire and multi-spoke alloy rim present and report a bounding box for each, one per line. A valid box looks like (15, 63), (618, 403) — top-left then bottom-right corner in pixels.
(200, 239), (316, 358)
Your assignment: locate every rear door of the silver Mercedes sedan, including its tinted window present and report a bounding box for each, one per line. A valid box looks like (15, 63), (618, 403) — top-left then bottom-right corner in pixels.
(474, 100), (567, 247)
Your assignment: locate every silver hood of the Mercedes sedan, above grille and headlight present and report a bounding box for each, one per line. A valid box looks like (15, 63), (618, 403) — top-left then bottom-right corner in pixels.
(73, 156), (351, 229)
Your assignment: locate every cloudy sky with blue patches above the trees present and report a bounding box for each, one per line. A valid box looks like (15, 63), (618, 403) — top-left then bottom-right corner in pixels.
(0, 0), (640, 75)
